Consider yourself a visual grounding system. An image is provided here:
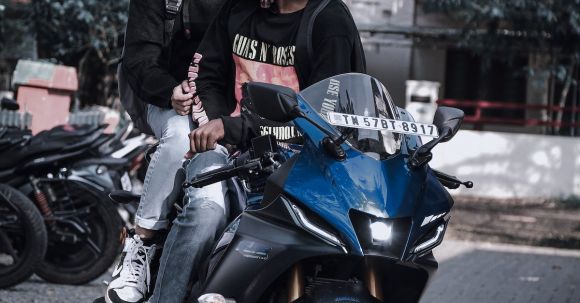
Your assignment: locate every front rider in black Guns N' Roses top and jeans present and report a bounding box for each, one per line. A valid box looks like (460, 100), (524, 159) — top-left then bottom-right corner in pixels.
(149, 0), (365, 303)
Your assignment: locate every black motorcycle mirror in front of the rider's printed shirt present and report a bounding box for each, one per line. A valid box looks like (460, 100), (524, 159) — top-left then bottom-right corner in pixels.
(242, 82), (300, 123)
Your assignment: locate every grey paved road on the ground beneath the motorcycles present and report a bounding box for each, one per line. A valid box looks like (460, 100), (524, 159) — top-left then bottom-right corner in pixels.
(0, 240), (580, 303)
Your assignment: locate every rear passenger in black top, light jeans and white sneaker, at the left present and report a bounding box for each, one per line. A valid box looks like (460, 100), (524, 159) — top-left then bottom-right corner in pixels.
(105, 0), (223, 303)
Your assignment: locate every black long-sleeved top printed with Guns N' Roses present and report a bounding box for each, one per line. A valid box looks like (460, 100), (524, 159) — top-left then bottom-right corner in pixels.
(195, 0), (365, 148)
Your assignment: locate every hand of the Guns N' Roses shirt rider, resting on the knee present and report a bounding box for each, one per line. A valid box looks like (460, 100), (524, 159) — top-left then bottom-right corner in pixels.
(188, 119), (225, 156)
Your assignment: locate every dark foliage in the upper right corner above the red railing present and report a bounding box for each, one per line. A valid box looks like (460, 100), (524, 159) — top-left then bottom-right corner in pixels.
(421, 0), (580, 133)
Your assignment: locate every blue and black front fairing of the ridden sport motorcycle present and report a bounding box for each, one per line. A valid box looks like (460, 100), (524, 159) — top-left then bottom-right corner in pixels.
(199, 74), (453, 302)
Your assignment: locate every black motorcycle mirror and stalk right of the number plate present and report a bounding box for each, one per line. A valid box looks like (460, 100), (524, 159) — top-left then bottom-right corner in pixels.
(409, 106), (465, 168)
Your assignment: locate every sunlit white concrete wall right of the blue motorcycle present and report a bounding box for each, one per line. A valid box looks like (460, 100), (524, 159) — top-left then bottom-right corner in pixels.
(430, 130), (580, 199)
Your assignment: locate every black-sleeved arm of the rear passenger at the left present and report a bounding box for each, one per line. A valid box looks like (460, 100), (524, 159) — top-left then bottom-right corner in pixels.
(122, 0), (181, 108)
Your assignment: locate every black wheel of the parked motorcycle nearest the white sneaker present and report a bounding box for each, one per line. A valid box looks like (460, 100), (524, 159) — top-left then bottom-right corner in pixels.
(36, 181), (123, 285)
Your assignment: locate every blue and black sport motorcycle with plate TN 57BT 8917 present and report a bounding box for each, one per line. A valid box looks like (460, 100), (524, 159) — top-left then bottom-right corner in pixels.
(188, 74), (472, 303)
